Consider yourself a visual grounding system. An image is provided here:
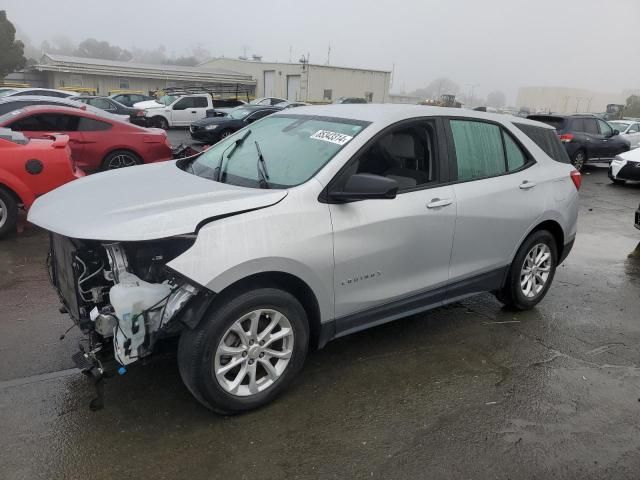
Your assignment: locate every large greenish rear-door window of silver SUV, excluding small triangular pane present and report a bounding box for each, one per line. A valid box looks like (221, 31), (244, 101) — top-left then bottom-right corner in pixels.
(449, 120), (506, 182)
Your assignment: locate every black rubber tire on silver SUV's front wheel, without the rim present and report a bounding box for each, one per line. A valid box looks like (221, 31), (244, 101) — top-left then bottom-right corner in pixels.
(178, 288), (309, 415)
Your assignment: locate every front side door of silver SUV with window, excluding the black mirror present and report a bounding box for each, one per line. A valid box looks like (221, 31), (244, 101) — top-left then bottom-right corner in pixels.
(329, 119), (456, 326)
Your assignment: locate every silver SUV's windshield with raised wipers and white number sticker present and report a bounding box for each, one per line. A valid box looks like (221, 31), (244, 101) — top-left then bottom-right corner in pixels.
(185, 115), (368, 188)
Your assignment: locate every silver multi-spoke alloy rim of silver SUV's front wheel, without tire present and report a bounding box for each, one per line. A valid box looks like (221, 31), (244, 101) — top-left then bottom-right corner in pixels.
(213, 309), (294, 397)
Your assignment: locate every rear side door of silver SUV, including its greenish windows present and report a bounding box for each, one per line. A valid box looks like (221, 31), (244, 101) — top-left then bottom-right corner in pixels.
(447, 118), (545, 299)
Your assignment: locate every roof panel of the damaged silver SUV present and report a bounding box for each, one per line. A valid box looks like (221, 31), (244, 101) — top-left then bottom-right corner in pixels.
(275, 103), (553, 129)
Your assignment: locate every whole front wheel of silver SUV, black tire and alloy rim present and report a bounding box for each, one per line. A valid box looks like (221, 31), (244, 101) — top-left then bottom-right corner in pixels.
(178, 288), (309, 414)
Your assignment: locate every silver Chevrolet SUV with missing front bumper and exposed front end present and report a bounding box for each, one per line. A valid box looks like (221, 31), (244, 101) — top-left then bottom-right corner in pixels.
(29, 105), (580, 413)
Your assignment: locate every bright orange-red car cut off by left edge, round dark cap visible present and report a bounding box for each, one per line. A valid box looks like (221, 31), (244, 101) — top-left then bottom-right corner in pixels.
(0, 128), (84, 237)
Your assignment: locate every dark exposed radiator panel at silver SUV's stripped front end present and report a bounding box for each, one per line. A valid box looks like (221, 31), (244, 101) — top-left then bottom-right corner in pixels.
(50, 233), (80, 321)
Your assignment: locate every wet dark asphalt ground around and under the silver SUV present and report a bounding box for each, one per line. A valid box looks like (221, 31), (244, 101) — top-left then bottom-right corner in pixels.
(0, 164), (640, 480)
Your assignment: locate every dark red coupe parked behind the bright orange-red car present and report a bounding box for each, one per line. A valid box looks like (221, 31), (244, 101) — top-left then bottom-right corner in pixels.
(0, 105), (172, 171)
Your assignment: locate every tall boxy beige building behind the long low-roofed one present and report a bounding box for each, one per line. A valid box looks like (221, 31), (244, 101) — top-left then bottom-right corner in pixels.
(199, 57), (391, 103)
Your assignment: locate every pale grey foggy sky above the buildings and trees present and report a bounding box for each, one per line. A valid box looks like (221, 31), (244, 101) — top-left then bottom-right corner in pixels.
(0, 0), (640, 103)
